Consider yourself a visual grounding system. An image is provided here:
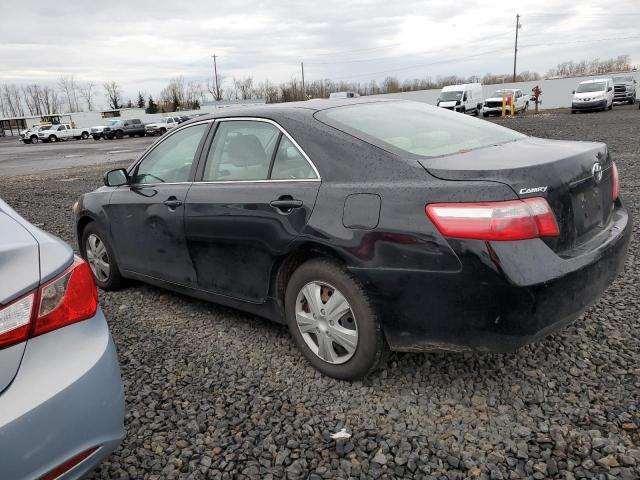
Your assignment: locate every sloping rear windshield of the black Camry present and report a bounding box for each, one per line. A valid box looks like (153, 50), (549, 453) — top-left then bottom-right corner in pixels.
(318, 101), (526, 157)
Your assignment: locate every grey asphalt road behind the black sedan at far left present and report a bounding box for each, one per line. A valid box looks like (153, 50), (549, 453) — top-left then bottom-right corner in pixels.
(0, 137), (158, 177)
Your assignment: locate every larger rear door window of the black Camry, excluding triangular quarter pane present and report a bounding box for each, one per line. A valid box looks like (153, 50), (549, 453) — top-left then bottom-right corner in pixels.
(203, 120), (280, 181)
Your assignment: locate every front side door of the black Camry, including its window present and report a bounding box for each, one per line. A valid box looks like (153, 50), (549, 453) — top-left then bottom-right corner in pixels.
(107, 123), (210, 285)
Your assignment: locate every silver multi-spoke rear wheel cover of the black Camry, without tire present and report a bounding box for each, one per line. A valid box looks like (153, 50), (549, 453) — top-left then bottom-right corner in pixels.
(295, 281), (358, 364)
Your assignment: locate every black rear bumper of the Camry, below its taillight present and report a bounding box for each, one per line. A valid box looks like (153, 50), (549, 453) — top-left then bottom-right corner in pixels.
(353, 202), (631, 352)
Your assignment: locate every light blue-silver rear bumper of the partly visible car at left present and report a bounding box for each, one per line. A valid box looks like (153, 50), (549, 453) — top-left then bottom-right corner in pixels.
(0, 310), (125, 480)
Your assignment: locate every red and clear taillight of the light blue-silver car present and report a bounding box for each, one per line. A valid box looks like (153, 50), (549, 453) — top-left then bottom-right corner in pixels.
(0, 257), (98, 348)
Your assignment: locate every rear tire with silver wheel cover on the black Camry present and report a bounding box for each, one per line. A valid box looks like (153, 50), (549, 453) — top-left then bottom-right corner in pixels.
(285, 259), (386, 380)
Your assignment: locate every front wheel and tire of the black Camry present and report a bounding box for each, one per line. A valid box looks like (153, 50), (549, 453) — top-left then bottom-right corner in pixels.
(80, 222), (125, 290)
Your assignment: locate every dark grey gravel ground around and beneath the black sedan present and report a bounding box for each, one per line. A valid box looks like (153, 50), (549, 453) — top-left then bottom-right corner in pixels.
(0, 107), (640, 479)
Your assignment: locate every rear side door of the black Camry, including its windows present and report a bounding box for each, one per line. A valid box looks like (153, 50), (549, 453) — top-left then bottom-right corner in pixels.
(185, 118), (320, 302)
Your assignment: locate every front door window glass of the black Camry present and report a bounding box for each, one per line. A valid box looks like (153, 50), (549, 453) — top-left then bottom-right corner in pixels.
(133, 123), (208, 183)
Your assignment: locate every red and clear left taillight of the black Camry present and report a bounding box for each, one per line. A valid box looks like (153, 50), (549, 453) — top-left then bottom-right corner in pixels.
(426, 197), (560, 240)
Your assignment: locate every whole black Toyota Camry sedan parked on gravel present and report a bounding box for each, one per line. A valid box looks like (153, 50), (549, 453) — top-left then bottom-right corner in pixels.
(74, 99), (631, 379)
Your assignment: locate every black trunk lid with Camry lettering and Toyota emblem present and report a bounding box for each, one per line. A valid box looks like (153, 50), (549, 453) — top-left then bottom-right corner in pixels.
(419, 137), (613, 253)
